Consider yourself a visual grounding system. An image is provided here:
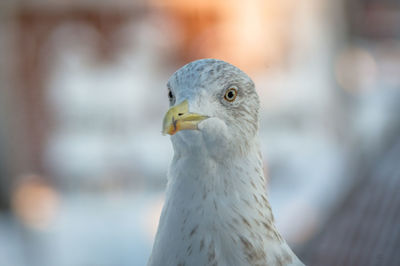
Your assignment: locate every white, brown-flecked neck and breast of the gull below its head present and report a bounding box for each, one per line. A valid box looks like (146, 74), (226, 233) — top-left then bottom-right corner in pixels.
(150, 140), (304, 265)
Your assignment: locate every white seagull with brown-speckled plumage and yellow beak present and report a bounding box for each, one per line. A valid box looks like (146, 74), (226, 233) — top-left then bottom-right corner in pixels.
(148, 59), (304, 266)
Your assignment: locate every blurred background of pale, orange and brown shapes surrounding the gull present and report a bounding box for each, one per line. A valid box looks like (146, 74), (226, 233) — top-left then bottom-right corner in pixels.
(0, 0), (400, 266)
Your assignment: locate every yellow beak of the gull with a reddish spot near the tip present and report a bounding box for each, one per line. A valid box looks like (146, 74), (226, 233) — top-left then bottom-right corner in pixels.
(162, 100), (208, 135)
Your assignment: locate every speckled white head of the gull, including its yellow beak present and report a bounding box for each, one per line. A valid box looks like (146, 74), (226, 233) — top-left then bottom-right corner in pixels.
(163, 59), (260, 156)
